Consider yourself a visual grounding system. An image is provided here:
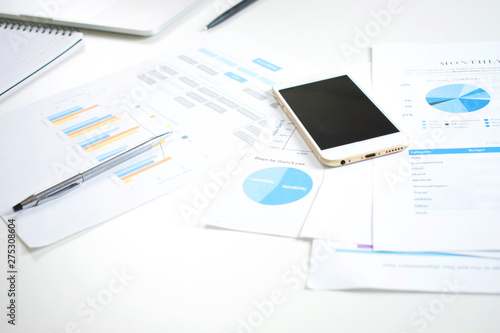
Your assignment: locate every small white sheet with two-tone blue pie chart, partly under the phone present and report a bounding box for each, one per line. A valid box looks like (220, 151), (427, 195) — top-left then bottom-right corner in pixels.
(202, 110), (325, 237)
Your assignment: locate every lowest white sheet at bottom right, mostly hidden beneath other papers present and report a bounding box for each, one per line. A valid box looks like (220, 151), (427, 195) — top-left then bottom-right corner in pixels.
(307, 240), (500, 299)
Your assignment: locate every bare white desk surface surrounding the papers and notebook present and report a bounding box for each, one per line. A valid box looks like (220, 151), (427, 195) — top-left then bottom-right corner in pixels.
(0, 0), (500, 333)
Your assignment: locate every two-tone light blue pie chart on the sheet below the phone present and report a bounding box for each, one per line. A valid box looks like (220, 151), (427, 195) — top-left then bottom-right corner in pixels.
(243, 167), (313, 205)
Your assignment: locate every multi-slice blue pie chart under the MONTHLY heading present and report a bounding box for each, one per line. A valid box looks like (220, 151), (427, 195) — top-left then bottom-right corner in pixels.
(425, 84), (491, 113)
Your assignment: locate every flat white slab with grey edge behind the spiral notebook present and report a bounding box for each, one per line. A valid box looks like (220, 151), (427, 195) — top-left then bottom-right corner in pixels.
(0, 0), (205, 36)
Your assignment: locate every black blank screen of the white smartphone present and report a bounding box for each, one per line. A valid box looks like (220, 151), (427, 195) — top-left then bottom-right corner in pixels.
(279, 75), (399, 150)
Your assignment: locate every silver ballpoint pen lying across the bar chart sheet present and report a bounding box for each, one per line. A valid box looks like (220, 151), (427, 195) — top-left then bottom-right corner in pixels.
(12, 132), (172, 212)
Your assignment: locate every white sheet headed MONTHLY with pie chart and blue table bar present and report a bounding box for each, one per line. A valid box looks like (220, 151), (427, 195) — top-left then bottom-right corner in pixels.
(373, 42), (500, 252)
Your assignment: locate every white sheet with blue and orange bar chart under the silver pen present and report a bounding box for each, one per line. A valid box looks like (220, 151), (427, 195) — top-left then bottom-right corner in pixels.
(0, 34), (304, 247)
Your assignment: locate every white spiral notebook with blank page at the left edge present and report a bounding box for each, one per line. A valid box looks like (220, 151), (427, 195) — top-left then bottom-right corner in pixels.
(0, 20), (83, 100)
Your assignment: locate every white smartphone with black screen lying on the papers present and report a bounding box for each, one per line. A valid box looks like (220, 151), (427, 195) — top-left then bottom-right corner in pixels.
(273, 74), (409, 167)
